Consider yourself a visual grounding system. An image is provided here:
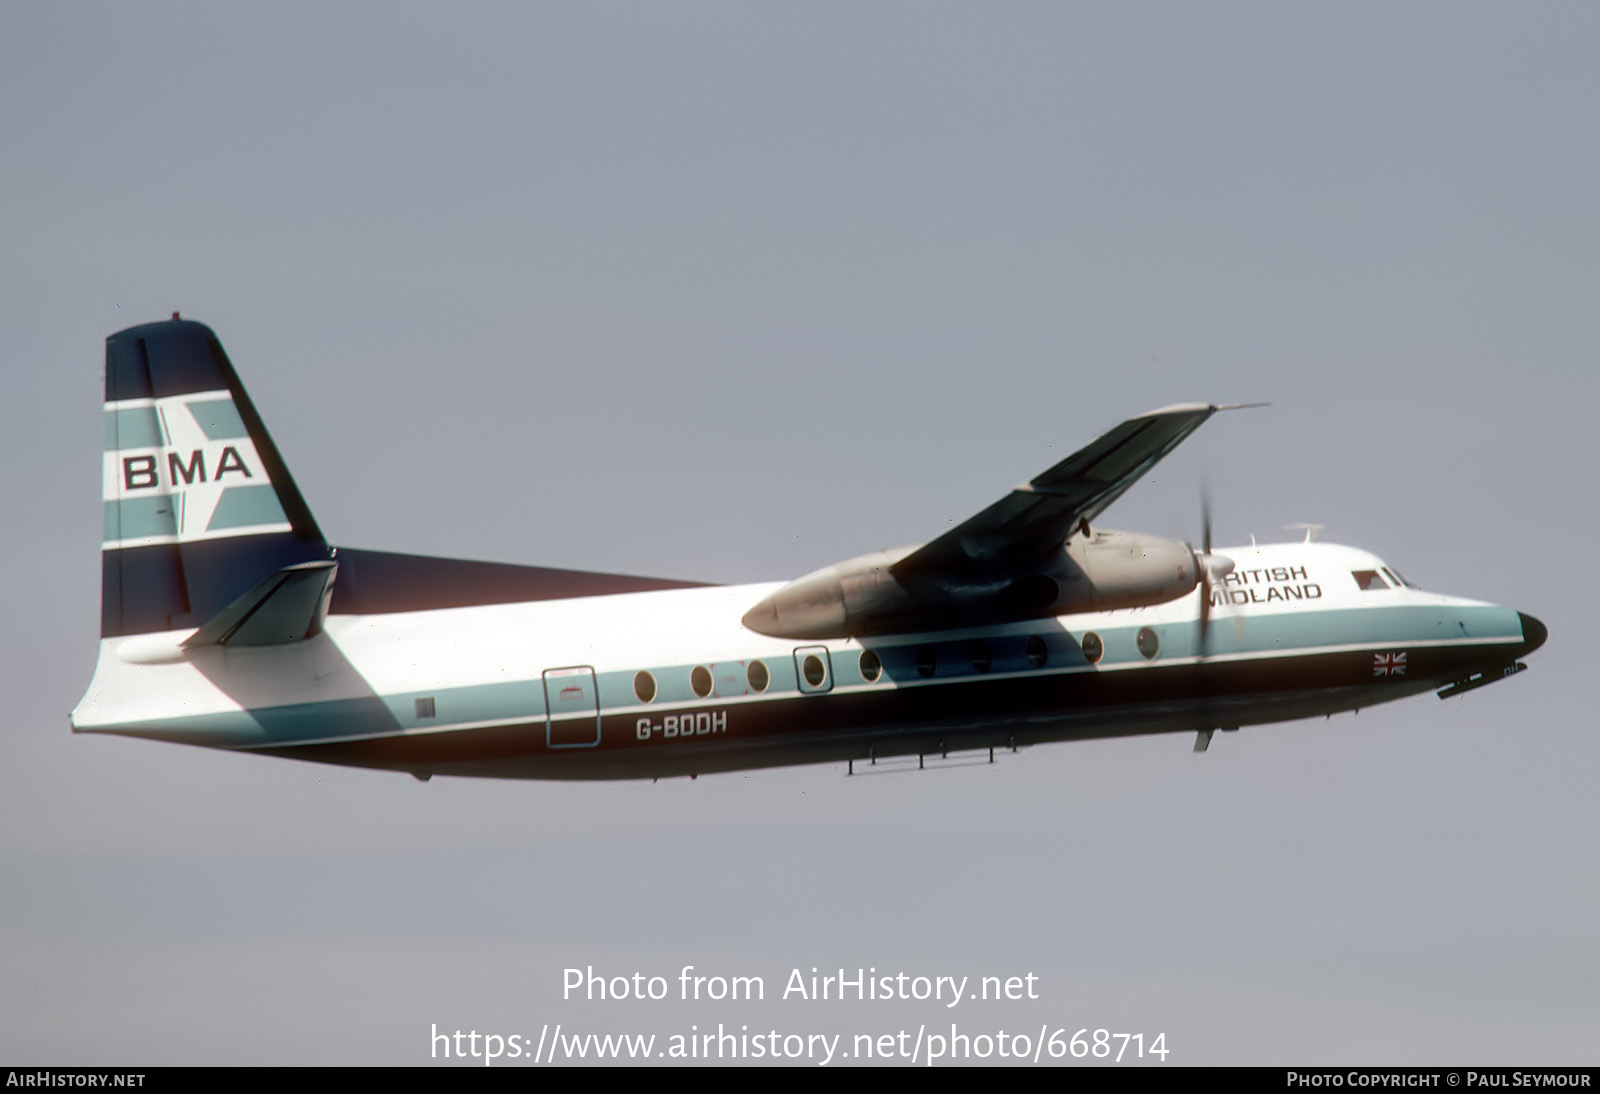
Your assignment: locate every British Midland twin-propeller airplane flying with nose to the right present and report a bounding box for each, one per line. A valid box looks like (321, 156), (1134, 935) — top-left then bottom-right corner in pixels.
(72, 312), (1547, 781)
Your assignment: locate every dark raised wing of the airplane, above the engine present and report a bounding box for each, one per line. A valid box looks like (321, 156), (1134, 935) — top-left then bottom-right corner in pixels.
(891, 403), (1230, 581)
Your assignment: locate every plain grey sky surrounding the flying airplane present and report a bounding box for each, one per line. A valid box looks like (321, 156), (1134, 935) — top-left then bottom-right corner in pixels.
(0, 3), (1600, 1064)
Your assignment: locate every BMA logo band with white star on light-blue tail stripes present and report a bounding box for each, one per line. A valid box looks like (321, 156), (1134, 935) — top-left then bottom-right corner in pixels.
(102, 390), (290, 550)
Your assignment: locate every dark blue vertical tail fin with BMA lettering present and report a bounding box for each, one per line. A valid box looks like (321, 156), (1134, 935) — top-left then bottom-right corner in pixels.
(101, 313), (330, 638)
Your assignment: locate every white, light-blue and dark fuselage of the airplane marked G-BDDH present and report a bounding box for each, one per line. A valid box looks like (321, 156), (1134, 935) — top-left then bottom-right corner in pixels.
(72, 544), (1526, 777)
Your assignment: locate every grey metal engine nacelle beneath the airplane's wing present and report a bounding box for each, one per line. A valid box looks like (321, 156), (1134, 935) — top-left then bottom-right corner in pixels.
(744, 531), (1203, 638)
